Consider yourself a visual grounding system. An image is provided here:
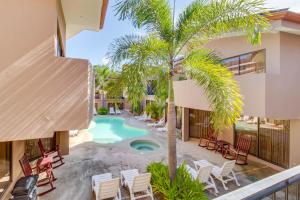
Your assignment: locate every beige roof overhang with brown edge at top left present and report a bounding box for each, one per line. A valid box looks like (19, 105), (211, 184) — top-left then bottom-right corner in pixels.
(61, 0), (108, 38)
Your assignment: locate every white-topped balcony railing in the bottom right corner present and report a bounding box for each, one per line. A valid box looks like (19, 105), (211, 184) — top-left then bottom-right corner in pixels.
(215, 165), (300, 200)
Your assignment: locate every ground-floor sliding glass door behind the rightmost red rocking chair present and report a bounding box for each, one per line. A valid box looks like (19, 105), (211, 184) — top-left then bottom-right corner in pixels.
(234, 116), (290, 168)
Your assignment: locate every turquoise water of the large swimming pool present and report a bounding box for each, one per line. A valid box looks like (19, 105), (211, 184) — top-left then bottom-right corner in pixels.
(89, 117), (148, 144)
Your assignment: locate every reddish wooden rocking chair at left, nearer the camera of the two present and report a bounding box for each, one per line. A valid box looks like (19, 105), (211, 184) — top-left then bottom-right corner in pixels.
(19, 154), (56, 196)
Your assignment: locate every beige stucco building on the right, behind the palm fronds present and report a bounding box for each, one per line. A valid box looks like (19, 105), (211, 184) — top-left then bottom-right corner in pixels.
(174, 10), (300, 168)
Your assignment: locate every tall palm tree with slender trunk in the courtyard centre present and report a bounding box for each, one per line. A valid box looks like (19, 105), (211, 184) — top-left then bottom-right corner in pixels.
(108, 0), (268, 180)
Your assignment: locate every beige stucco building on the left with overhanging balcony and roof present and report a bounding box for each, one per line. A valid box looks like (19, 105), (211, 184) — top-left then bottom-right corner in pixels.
(0, 0), (108, 199)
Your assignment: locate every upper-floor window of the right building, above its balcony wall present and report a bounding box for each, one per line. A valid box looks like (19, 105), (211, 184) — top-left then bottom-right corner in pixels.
(223, 50), (266, 75)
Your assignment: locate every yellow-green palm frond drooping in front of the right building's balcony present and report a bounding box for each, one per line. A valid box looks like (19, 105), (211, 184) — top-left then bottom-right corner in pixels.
(184, 49), (243, 129)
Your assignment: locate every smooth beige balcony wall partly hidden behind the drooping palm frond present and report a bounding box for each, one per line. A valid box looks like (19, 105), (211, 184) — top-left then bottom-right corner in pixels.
(174, 73), (266, 116)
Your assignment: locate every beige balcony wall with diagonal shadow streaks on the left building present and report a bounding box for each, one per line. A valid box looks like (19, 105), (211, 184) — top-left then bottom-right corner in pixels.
(0, 40), (94, 141)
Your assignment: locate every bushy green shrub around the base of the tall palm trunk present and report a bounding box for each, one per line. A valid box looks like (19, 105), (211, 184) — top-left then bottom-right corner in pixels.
(147, 162), (208, 200)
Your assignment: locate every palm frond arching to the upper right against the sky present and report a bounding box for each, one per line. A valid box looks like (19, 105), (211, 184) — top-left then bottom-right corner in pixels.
(176, 0), (269, 54)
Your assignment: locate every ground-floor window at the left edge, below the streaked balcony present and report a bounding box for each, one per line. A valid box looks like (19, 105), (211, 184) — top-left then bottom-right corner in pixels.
(0, 142), (12, 198)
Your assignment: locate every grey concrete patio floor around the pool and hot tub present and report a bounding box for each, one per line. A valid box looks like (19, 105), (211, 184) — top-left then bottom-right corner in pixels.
(39, 115), (277, 200)
